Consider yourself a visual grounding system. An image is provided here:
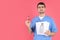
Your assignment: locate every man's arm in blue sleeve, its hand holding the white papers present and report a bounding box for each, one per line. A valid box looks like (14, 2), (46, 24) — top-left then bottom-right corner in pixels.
(45, 19), (57, 36)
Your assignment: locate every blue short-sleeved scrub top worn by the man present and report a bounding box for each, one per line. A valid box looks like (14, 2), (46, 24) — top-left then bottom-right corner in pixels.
(30, 16), (57, 40)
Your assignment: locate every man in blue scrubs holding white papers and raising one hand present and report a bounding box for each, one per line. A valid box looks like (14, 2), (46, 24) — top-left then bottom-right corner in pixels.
(25, 2), (57, 40)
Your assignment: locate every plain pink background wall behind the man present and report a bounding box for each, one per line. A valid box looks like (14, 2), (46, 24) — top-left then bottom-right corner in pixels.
(0, 0), (60, 40)
